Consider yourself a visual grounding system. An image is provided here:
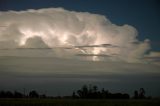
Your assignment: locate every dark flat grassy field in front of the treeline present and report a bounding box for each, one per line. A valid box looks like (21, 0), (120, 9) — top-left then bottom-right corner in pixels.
(0, 99), (160, 106)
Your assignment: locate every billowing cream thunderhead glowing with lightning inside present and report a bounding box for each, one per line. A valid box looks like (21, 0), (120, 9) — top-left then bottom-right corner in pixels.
(0, 8), (159, 62)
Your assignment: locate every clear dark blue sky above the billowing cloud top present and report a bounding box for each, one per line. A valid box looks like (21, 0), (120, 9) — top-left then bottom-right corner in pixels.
(0, 0), (160, 51)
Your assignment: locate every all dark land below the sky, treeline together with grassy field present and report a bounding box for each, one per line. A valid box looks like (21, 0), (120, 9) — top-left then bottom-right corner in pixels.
(0, 85), (160, 106)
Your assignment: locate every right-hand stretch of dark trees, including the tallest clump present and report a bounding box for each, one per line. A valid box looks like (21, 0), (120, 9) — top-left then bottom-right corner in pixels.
(72, 85), (151, 99)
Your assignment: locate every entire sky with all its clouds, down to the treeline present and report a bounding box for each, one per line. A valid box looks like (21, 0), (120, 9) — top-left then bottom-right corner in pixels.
(0, 0), (160, 96)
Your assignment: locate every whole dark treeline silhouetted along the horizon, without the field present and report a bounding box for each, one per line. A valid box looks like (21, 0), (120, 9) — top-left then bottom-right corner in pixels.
(0, 85), (151, 99)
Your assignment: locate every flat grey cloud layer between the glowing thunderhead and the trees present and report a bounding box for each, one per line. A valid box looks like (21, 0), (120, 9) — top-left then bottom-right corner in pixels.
(0, 57), (160, 96)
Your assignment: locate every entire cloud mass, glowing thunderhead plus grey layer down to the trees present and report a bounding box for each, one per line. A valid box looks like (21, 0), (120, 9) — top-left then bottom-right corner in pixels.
(0, 8), (160, 96)
